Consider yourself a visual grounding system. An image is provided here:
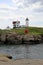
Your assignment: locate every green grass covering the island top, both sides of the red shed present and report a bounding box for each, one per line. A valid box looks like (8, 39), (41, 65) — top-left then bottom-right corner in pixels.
(0, 27), (43, 34)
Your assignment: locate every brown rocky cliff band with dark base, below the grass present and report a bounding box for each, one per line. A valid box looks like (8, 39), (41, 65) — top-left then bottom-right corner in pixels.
(0, 33), (43, 45)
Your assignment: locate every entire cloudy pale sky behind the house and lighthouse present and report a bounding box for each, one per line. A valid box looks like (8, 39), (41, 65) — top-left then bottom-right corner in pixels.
(0, 0), (43, 29)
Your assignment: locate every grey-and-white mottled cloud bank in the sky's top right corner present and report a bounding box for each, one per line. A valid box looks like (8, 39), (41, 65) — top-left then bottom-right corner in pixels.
(12, 0), (43, 12)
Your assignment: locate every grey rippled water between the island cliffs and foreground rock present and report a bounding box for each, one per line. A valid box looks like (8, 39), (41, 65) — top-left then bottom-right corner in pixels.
(0, 44), (43, 59)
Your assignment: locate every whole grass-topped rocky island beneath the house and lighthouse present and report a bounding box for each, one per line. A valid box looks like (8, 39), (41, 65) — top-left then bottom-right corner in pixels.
(0, 27), (43, 45)
